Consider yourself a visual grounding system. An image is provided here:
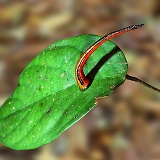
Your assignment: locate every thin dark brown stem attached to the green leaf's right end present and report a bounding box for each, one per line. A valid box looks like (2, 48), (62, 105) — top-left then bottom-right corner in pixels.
(126, 74), (160, 93)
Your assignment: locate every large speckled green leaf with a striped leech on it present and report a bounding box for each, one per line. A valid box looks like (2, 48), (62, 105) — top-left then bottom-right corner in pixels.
(0, 35), (128, 150)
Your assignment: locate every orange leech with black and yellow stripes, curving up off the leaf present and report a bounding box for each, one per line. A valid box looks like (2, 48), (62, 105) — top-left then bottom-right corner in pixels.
(75, 24), (143, 91)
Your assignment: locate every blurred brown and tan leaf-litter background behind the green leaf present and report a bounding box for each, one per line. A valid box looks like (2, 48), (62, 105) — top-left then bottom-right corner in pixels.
(0, 0), (160, 160)
